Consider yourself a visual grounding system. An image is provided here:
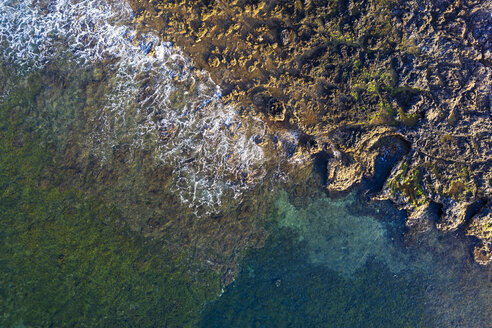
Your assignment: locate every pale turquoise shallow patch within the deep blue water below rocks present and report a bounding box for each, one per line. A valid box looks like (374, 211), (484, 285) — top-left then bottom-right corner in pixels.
(275, 193), (405, 277)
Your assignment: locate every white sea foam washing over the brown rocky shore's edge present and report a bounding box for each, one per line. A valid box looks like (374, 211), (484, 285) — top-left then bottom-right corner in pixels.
(0, 0), (264, 212)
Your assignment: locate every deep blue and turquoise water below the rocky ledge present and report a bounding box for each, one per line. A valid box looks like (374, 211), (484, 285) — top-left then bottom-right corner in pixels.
(201, 186), (491, 327)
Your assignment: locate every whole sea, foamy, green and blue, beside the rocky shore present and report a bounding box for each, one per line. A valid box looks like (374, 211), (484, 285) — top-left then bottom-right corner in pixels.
(0, 0), (492, 327)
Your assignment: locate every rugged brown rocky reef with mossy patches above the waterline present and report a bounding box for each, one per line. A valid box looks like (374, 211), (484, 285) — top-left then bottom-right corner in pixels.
(130, 0), (492, 265)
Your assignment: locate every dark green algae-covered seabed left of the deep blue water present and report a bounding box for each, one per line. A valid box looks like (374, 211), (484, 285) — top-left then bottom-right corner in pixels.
(0, 66), (220, 327)
